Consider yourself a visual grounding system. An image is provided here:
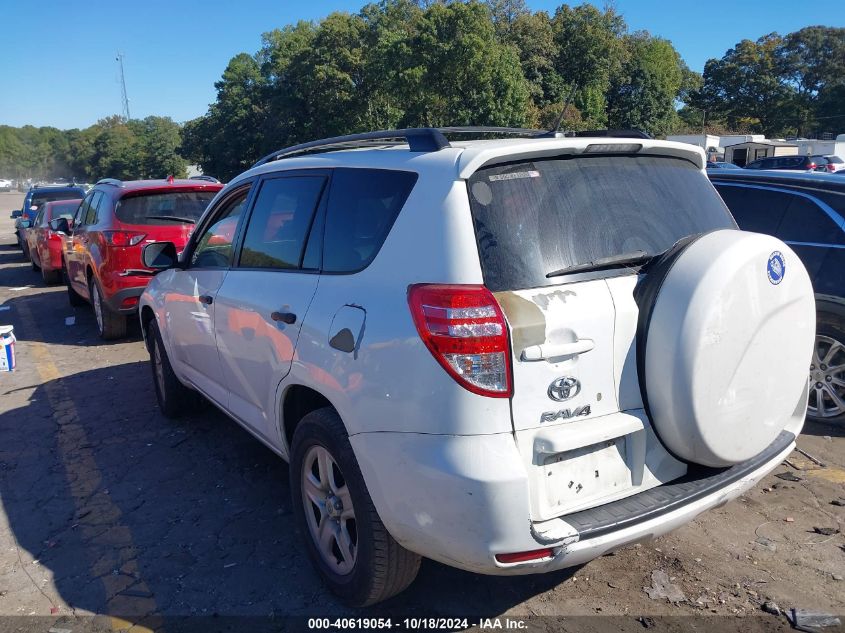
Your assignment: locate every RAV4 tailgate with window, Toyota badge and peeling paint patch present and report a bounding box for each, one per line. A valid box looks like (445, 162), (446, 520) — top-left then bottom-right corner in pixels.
(468, 152), (735, 520)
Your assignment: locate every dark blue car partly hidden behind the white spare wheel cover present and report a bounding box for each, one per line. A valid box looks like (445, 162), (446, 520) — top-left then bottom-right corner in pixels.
(709, 172), (845, 422)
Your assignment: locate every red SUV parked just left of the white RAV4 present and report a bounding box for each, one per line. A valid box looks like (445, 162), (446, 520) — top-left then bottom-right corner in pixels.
(58, 178), (223, 339)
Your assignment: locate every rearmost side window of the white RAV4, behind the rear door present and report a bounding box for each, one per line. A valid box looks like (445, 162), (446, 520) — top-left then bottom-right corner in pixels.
(323, 169), (417, 273)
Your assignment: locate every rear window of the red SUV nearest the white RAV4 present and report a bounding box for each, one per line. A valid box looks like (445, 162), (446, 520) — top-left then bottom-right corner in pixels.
(115, 191), (217, 225)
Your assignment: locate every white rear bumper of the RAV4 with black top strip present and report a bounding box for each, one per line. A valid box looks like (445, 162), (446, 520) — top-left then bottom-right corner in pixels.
(350, 431), (795, 575)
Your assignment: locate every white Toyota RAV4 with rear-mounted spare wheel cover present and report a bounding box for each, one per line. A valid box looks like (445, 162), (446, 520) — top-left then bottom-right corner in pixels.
(140, 128), (815, 605)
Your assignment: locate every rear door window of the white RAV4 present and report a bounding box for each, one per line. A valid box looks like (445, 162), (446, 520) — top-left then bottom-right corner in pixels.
(238, 176), (326, 269)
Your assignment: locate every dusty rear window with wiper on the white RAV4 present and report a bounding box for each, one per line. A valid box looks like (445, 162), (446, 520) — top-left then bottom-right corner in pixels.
(468, 155), (736, 291)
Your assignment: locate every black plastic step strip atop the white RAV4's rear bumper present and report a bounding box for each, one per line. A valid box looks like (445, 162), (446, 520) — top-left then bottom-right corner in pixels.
(560, 431), (795, 541)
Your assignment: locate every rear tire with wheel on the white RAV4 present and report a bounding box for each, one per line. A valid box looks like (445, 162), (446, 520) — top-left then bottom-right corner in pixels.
(290, 408), (420, 607)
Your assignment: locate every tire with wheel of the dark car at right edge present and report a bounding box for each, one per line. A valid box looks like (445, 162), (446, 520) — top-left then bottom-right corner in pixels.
(807, 301), (845, 424)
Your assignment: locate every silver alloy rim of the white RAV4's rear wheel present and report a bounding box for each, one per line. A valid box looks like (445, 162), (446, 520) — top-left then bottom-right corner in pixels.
(300, 445), (358, 576)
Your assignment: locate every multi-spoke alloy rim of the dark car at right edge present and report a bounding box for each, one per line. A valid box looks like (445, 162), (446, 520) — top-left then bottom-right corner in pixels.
(807, 334), (845, 418)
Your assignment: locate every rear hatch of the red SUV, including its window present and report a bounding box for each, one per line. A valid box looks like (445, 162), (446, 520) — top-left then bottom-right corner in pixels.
(110, 187), (220, 270)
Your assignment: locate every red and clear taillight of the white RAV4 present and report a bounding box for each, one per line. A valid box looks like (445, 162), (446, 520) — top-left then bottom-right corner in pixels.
(408, 284), (511, 398)
